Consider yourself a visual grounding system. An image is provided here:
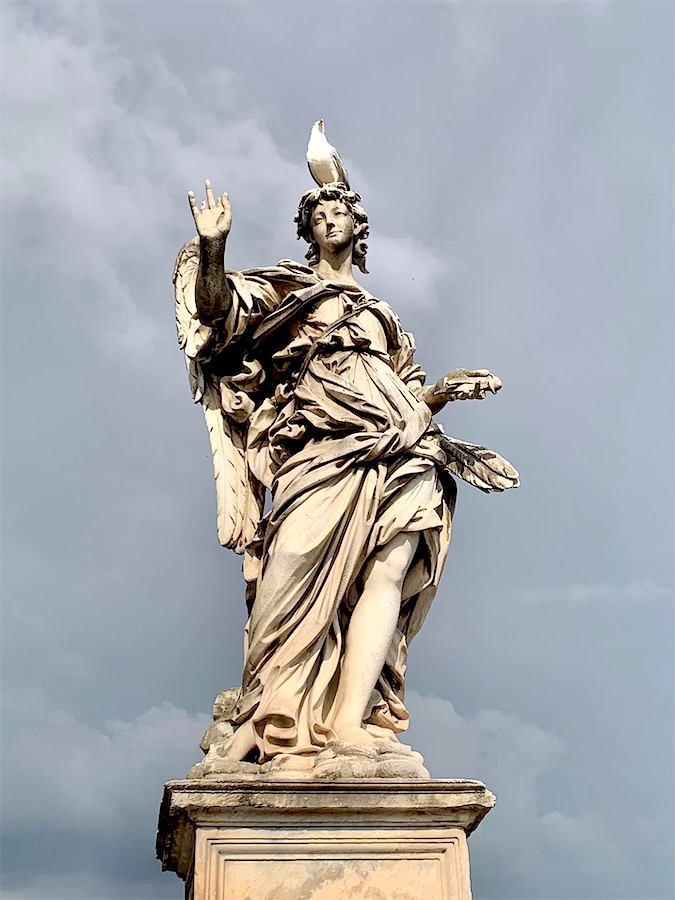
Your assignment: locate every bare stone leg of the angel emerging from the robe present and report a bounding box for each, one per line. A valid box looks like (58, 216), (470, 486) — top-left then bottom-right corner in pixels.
(332, 532), (419, 744)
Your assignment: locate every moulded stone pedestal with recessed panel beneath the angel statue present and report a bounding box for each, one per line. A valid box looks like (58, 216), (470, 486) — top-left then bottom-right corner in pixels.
(157, 778), (495, 900)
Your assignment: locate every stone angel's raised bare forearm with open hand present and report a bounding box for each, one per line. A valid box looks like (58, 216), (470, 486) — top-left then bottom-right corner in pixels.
(188, 180), (232, 325)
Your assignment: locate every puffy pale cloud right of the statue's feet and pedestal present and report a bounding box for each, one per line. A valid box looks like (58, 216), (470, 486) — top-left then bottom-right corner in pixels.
(408, 691), (630, 900)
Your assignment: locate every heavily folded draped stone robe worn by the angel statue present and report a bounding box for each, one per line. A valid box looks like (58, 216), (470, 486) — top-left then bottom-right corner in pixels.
(190, 261), (455, 761)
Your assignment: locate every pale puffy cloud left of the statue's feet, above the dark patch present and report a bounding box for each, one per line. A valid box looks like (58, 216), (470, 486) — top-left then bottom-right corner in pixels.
(3, 689), (209, 833)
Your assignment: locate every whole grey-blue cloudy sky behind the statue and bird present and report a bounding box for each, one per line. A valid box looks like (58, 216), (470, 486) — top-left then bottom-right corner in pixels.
(2, 0), (673, 900)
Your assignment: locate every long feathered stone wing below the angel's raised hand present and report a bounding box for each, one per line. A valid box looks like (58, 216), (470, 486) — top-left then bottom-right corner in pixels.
(173, 238), (264, 553)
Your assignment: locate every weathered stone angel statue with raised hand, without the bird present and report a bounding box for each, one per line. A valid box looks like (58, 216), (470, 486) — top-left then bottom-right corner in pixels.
(174, 126), (518, 777)
